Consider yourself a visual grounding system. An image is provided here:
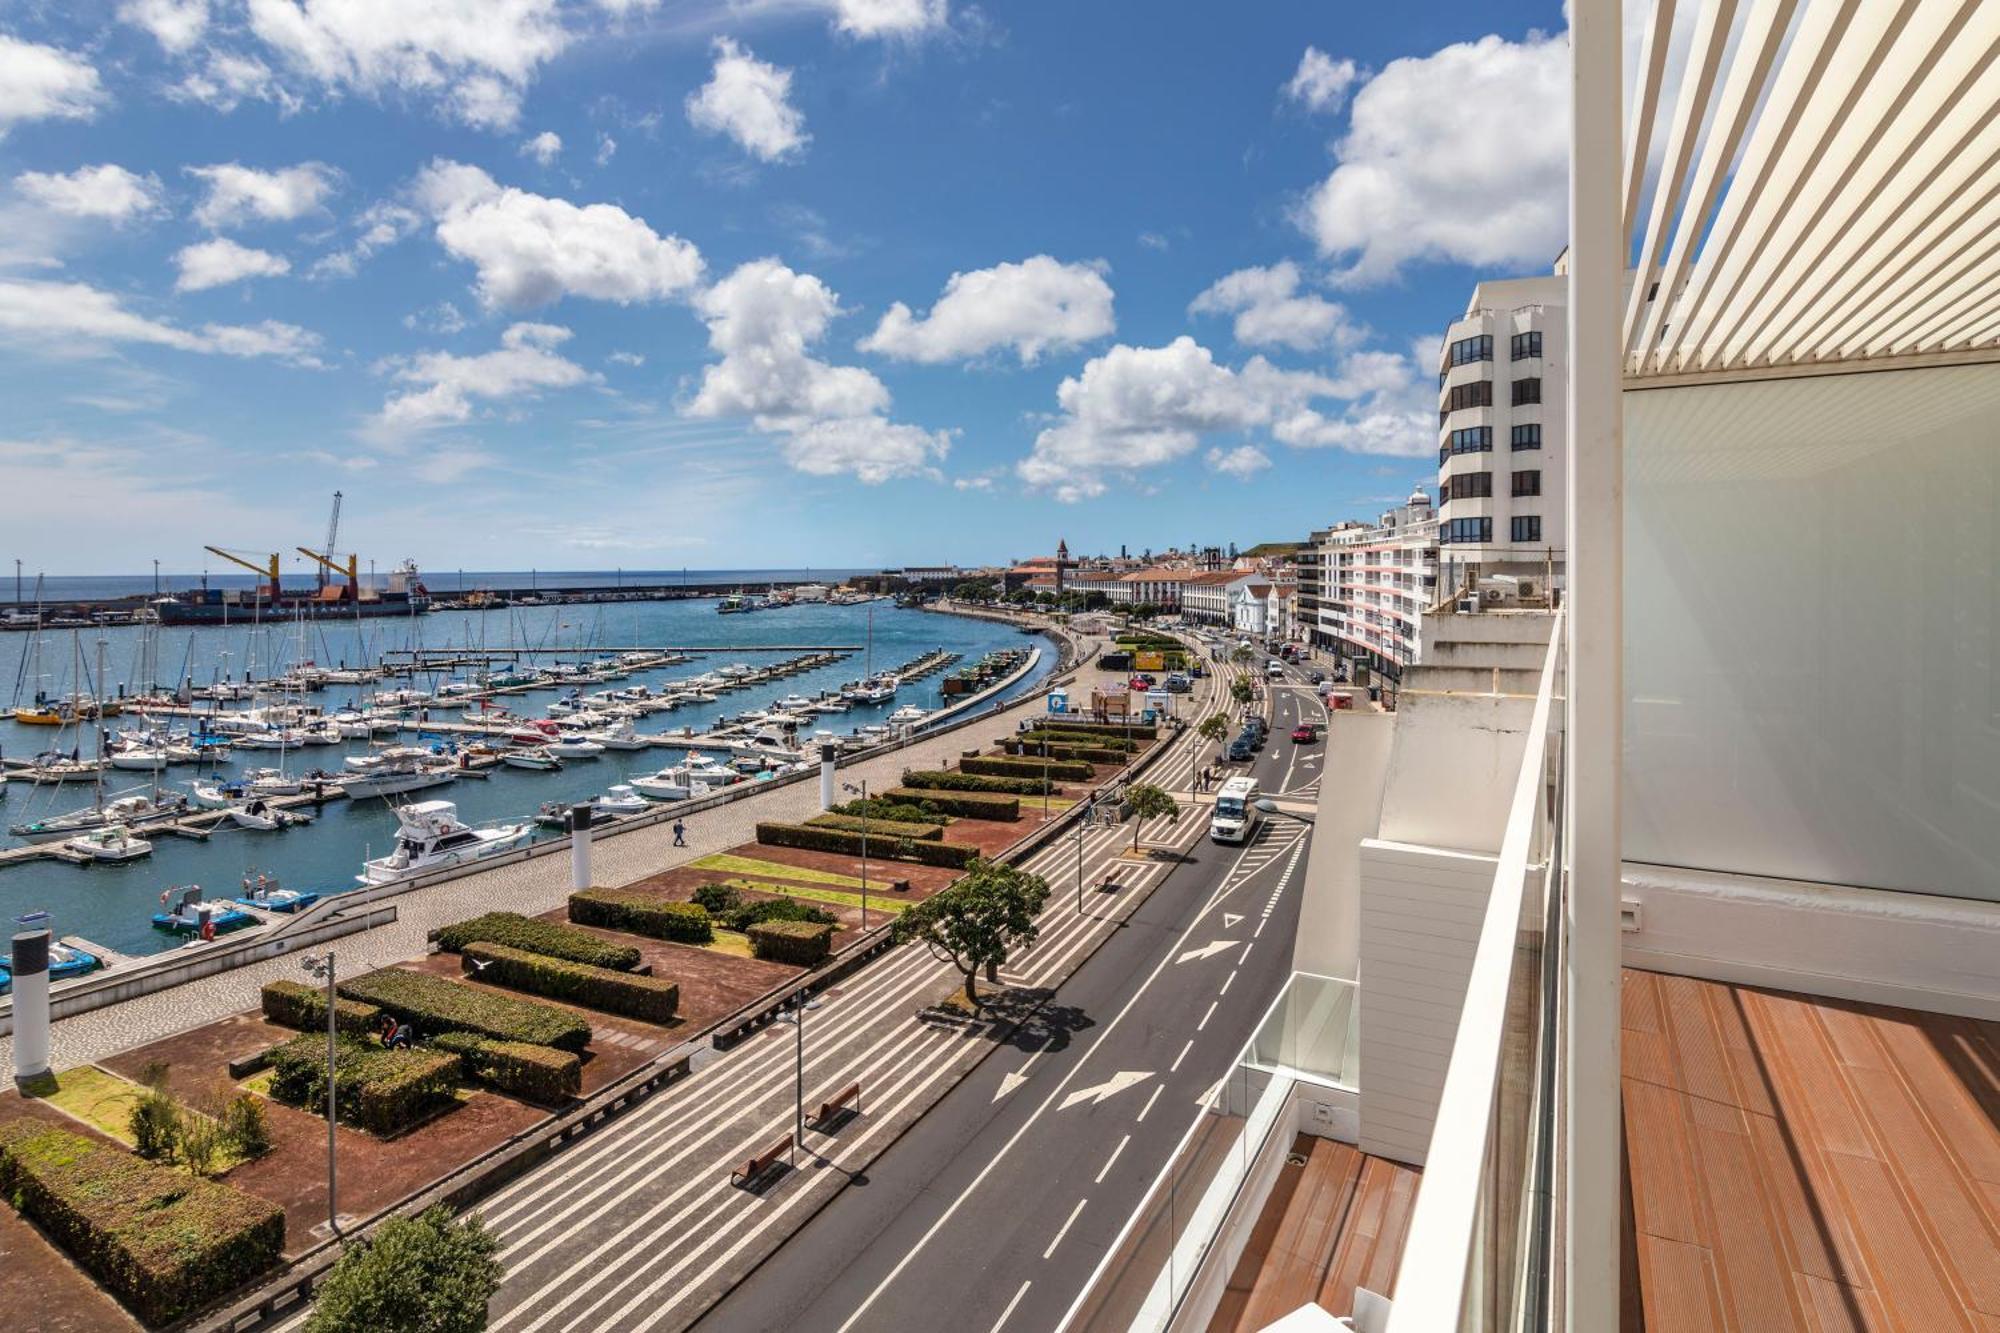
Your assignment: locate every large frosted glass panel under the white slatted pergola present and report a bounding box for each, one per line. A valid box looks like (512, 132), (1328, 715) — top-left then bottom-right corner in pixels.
(1626, 366), (2000, 901)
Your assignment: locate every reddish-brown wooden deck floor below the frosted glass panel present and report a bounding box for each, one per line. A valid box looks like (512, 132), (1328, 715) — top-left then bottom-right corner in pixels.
(1624, 971), (2000, 1333)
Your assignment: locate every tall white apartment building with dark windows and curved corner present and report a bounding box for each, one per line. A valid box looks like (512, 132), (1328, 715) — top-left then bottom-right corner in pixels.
(1438, 260), (1568, 592)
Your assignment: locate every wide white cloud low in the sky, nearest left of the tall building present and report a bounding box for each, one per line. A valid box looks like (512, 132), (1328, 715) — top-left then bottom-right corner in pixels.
(1018, 336), (1334, 500)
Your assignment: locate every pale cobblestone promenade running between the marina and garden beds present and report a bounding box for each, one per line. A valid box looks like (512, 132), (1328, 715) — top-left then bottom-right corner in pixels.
(0, 636), (1088, 1089)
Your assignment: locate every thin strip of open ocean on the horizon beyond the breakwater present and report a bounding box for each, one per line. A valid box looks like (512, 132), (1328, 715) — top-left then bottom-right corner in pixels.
(0, 556), (878, 606)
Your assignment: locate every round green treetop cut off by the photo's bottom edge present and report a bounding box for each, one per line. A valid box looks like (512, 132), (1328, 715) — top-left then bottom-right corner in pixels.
(306, 1203), (500, 1333)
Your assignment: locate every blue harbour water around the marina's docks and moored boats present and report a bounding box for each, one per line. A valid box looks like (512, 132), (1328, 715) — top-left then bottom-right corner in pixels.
(0, 598), (1054, 953)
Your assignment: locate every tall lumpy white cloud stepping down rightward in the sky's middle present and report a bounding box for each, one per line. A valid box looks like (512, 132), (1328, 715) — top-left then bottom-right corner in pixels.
(686, 258), (950, 484)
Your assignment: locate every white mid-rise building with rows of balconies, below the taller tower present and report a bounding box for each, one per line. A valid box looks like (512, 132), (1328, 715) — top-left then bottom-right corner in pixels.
(1320, 488), (1438, 677)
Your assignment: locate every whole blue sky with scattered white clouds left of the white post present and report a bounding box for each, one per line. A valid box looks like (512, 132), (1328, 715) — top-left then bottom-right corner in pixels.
(0, 0), (1566, 572)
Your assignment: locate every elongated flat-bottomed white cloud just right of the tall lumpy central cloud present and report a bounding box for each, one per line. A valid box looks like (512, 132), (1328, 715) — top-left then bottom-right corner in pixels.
(860, 254), (1118, 366)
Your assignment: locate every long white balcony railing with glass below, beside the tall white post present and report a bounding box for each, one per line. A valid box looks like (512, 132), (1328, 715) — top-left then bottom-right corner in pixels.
(1392, 612), (1564, 1333)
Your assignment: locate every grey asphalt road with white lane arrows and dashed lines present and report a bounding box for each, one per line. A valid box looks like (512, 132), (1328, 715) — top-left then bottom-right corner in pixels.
(698, 660), (1326, 1333)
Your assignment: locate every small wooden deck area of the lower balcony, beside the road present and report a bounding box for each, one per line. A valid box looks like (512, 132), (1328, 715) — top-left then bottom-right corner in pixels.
(1208, 1135), (1420, 1333)
